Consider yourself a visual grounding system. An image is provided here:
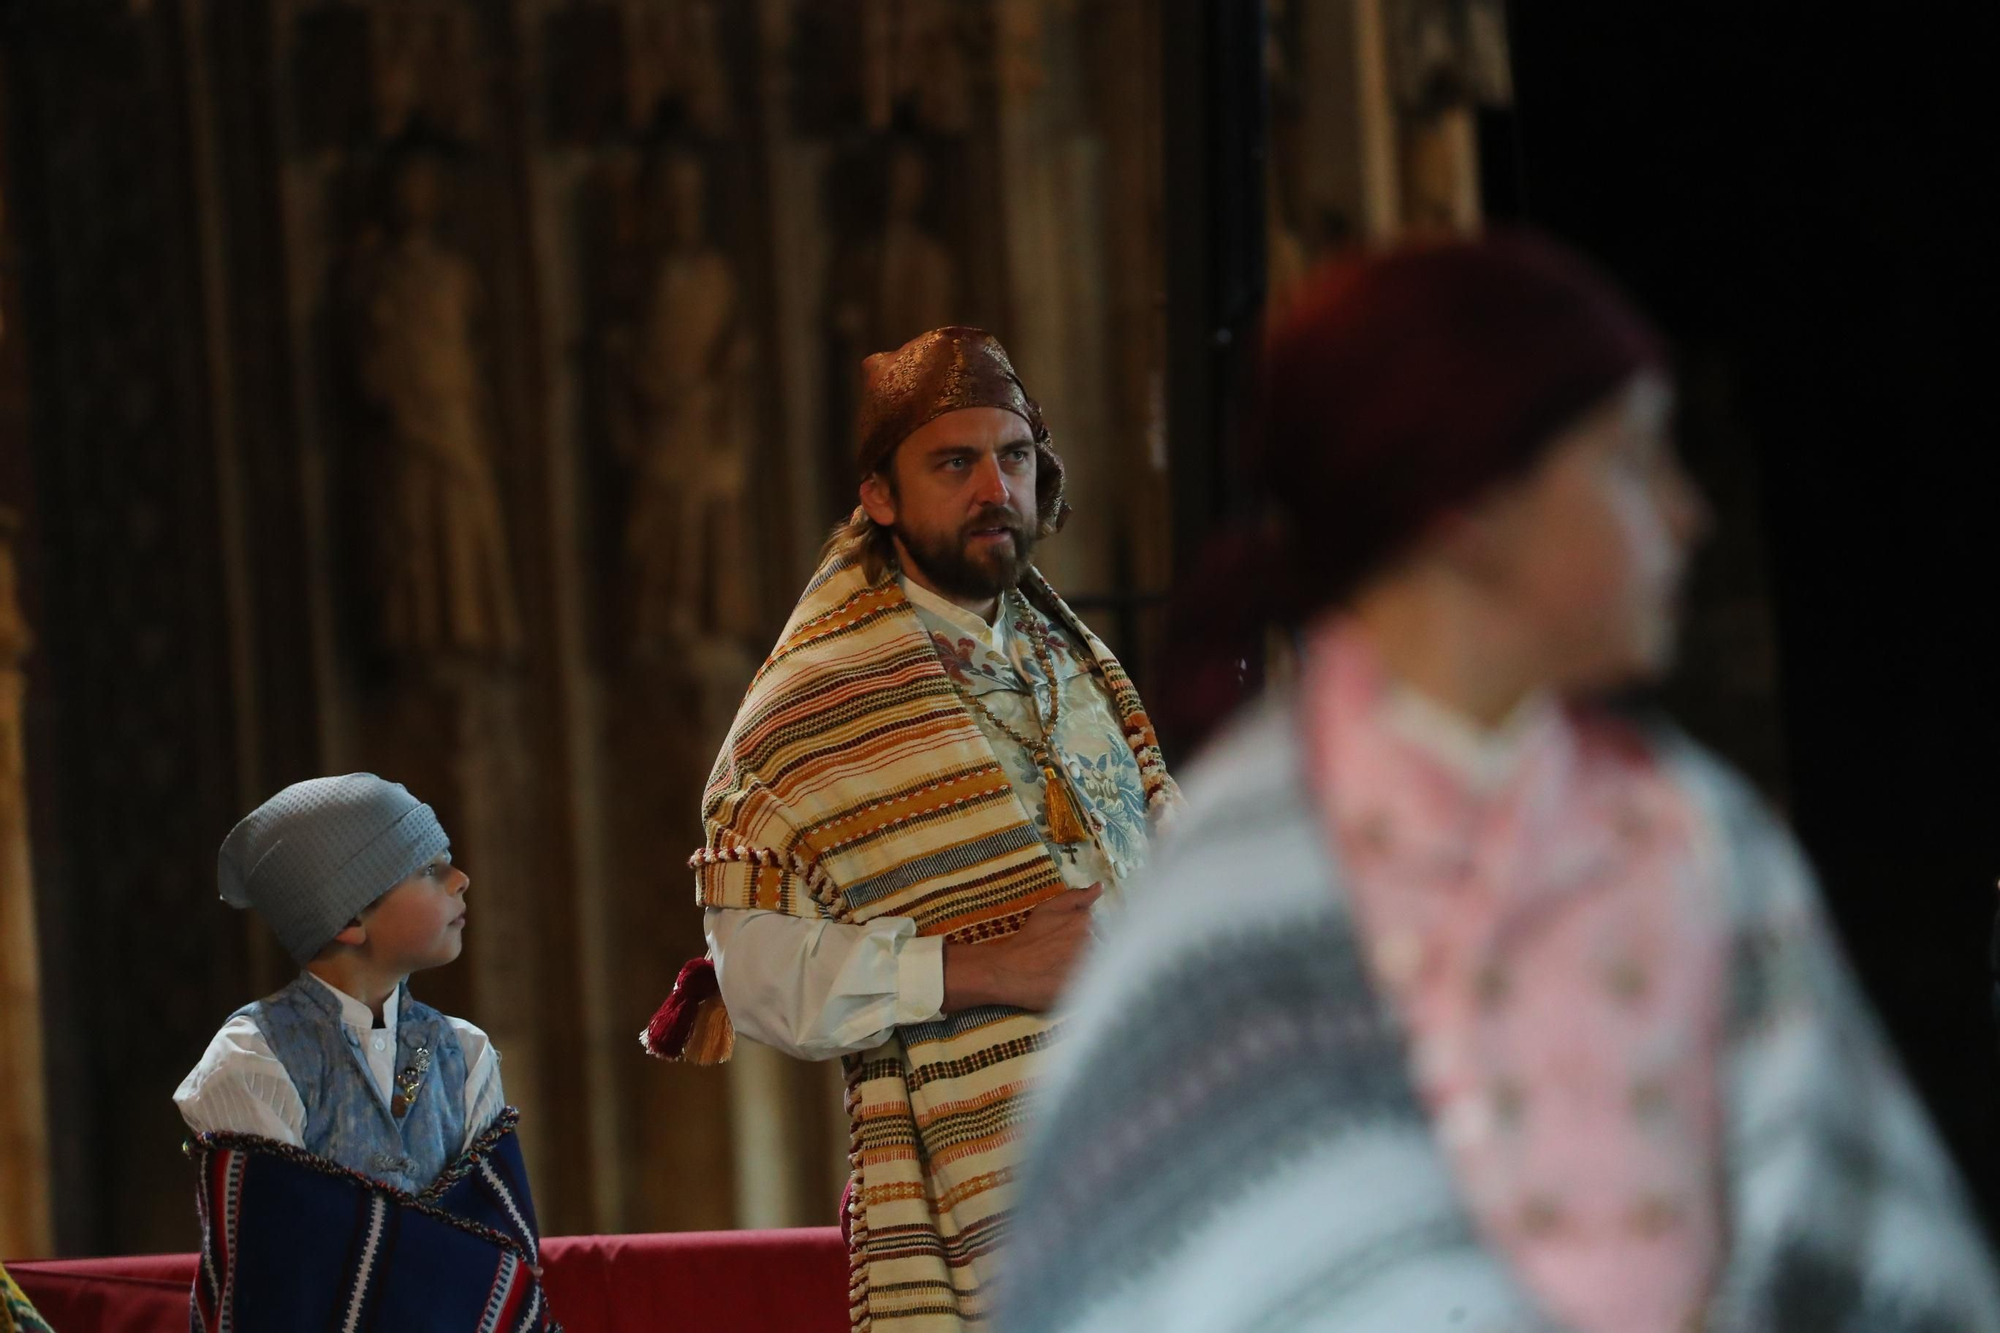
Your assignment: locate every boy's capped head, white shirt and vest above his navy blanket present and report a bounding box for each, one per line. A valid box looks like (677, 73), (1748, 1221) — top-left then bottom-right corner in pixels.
(174, 773), (502, 1193)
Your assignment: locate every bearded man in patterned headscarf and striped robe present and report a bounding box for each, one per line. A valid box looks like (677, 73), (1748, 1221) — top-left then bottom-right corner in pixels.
(648, 326), (1178, 1333)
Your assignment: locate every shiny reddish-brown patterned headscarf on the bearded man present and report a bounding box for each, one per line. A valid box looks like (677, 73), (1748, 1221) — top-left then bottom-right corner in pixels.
(854, 324), (1070, 536)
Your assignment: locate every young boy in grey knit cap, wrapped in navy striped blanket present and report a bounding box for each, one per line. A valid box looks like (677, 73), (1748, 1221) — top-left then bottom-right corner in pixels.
(174, 773), (552, 1331)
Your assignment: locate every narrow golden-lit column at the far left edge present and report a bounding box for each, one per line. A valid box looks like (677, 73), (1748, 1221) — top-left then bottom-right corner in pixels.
(0, 508), (50, 1255)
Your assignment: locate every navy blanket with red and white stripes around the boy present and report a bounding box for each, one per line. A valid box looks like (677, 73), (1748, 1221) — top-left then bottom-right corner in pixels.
(188, 1109), (562, 1333)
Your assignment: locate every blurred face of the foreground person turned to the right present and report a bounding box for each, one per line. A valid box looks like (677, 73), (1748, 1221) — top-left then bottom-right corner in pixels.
(1472, 372), (1708, 689)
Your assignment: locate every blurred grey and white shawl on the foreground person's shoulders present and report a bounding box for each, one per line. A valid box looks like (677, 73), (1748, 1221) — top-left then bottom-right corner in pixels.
(996, 701), (2000, 1333)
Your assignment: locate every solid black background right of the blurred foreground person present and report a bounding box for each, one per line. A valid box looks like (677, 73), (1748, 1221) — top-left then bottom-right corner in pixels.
(1486, 0), (2000, 1227)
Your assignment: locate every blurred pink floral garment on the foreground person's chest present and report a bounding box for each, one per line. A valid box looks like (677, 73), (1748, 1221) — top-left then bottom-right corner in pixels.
(1304, 624), (1728, 1333)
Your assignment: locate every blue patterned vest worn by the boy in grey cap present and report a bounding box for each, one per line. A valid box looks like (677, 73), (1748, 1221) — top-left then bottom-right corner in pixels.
(238, 975), (466, 1193)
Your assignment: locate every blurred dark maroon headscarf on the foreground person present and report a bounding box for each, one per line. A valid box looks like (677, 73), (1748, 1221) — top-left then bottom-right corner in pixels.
(1152, 232), (1666, 756)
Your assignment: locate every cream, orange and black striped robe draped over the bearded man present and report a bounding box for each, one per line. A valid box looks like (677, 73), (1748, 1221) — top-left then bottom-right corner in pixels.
(692, 556), (1178, 1333)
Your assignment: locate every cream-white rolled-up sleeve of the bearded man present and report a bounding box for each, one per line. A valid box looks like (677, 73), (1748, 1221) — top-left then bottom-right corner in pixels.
(702, 907), (944, 1061)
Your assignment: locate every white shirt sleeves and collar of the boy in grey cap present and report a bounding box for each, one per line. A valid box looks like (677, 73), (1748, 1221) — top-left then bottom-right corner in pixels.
(174, 973), (506, 1147)
